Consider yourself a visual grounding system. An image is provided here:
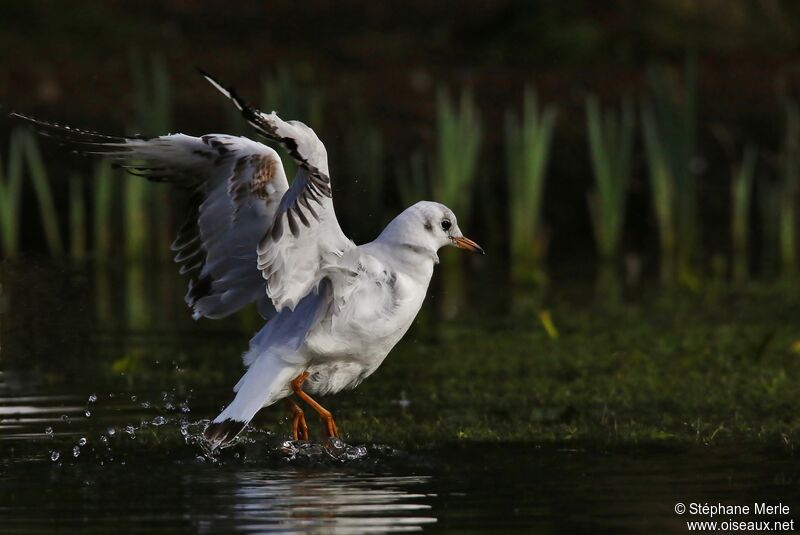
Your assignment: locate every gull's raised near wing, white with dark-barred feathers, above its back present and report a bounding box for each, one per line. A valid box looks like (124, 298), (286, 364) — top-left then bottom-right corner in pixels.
(201, 71), (355, 310)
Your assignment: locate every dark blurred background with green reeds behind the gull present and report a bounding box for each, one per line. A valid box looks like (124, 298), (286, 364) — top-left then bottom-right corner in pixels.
(0, 0), (800, 294)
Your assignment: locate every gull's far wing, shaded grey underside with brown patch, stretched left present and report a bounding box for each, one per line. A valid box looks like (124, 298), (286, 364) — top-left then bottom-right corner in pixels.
(15, 115), (289, 319)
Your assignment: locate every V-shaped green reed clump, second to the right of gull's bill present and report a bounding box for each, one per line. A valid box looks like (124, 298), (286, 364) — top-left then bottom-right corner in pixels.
(586, 96), (635, 262)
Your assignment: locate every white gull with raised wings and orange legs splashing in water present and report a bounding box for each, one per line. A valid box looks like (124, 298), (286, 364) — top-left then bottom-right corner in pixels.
(12, 71), (483, 448)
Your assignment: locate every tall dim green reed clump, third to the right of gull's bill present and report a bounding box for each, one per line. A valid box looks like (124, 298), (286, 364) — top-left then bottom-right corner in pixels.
(642, 57), (700, 285)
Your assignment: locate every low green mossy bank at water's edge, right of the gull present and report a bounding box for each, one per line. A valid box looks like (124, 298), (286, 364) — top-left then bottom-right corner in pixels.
(335, 289), (800, 448)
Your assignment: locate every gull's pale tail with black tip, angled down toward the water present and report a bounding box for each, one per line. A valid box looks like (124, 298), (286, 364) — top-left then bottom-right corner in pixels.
(203, 279), (330, 448)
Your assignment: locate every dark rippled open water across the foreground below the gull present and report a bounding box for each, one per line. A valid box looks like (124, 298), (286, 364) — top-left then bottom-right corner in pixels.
(0, 382), (800, 533)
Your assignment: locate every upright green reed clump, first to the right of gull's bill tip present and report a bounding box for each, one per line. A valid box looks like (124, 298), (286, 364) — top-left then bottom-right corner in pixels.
(505, 88), (557, 283)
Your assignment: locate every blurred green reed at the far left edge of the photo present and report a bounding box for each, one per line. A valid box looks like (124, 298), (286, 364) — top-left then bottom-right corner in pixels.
(0, 130), (24, 258)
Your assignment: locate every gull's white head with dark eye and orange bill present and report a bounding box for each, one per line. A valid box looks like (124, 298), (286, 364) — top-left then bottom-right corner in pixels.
(384, 201), (485, 254)
